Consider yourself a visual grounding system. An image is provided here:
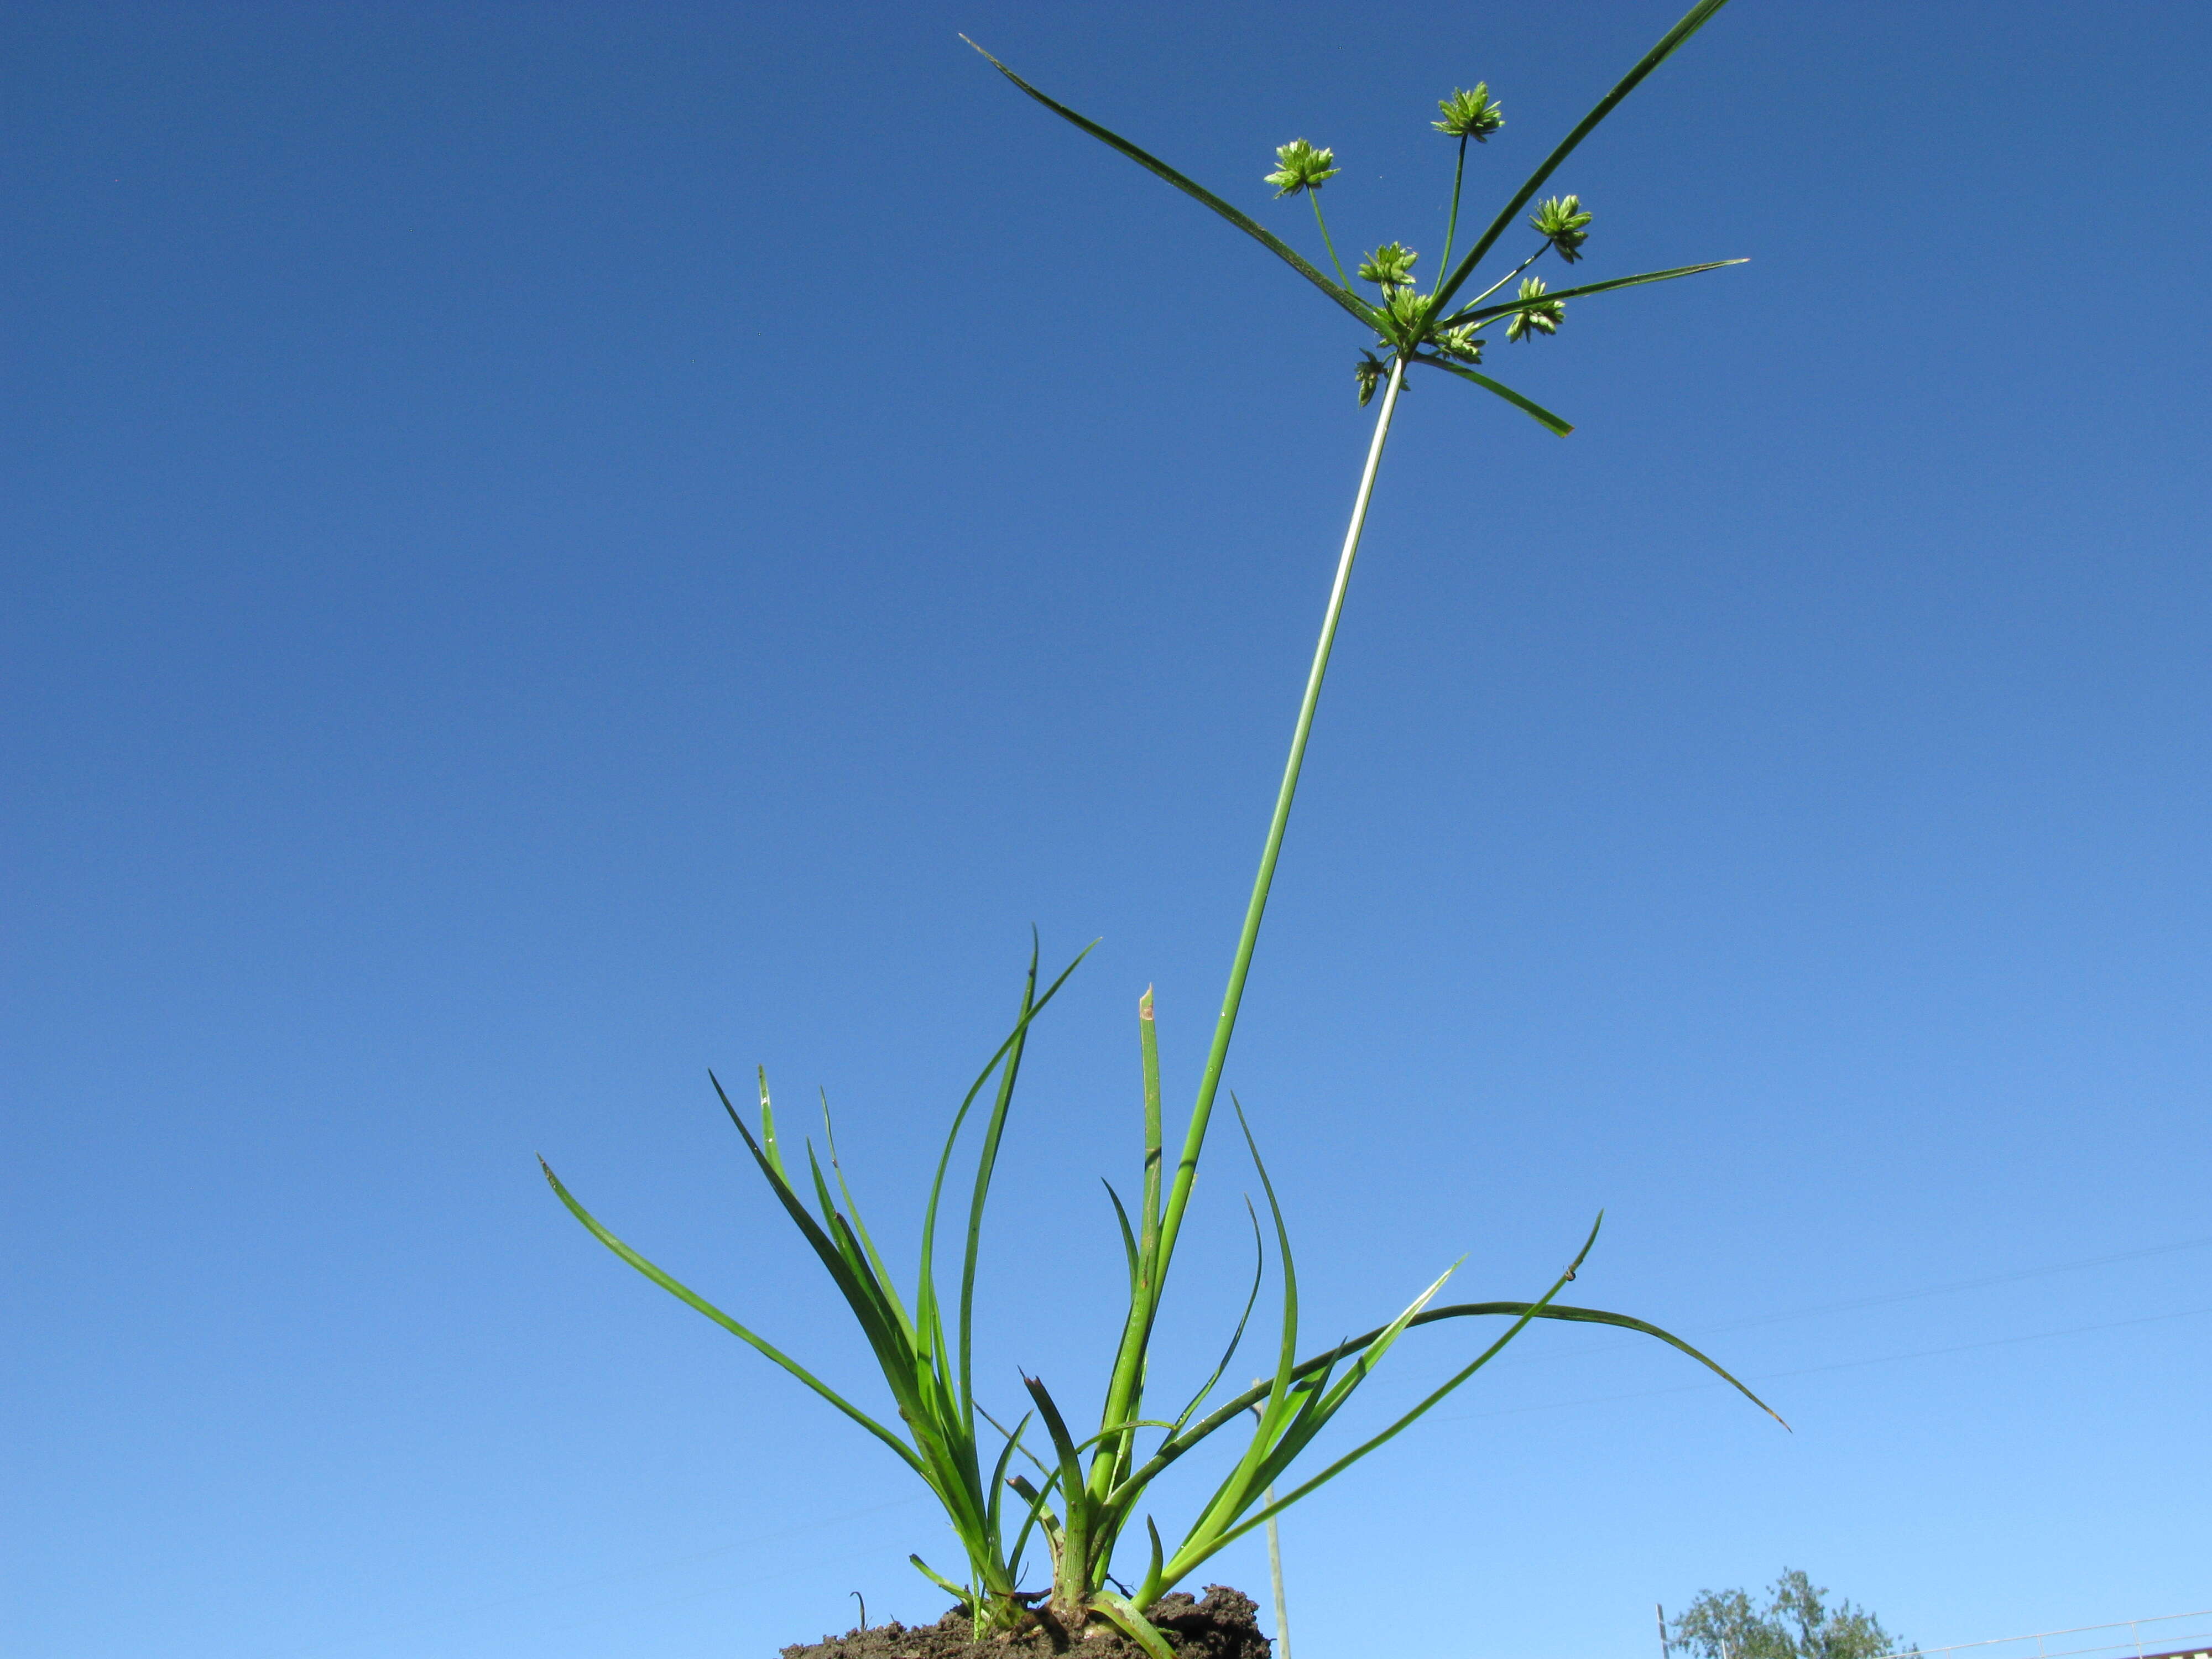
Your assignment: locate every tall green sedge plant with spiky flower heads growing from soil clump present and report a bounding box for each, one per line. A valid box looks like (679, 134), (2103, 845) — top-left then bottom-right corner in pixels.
(544, 0), (1765, 1659)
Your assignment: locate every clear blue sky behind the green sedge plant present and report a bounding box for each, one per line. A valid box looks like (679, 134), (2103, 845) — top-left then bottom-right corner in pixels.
(0, 0), (2212, 1659)
